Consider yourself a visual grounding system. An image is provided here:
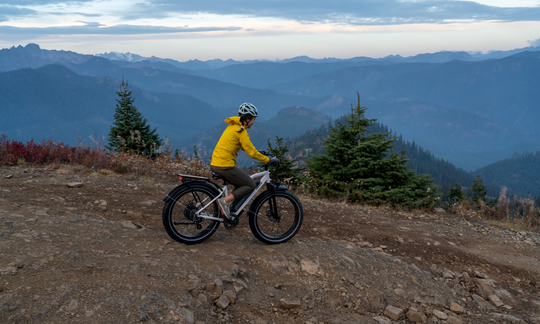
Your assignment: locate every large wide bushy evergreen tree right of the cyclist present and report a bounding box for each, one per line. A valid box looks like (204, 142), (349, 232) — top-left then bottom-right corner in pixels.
(307, 96), (438, 208)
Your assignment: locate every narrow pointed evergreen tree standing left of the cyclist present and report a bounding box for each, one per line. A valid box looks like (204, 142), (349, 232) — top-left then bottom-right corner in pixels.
(107, 78), (163, 154)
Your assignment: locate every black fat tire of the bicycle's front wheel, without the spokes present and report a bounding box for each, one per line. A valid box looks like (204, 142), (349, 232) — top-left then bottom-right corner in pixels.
(248, 190), (304, 244)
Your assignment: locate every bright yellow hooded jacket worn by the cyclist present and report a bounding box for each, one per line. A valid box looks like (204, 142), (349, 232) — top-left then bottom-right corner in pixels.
(210, 116), (270, 168)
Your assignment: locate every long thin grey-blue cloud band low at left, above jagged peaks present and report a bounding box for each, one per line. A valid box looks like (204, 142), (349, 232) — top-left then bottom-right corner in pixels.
(0, 22), (242, 36)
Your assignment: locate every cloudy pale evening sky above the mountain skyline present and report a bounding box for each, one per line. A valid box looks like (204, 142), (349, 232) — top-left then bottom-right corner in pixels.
(0, 0), (540, 61)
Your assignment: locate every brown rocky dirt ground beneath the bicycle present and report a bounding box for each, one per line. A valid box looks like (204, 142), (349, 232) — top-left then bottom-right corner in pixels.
(0, 166), (540, 324)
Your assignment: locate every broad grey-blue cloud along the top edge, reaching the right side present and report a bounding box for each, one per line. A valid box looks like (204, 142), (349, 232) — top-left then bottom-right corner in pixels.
(147, 0), (540, 25)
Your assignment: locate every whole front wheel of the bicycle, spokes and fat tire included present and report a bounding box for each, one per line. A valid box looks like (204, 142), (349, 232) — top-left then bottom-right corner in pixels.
(248, 190), (304, 244)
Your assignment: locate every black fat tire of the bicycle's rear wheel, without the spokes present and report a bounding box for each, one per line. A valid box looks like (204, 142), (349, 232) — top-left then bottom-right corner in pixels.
(162, 182), (220, 245)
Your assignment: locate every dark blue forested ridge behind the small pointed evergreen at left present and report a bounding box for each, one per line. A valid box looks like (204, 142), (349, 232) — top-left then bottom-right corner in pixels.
(0, 65), (227, 144)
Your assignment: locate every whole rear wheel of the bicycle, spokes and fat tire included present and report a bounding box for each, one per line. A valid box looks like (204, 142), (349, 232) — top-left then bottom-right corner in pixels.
(162, 183), (220, 244)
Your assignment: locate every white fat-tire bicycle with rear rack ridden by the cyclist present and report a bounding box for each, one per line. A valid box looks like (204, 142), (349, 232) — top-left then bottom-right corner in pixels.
(162, 158), (304, 245)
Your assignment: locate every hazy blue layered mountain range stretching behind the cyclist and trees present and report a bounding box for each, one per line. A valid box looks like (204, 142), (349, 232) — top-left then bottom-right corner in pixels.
(0, 44), (540, 175)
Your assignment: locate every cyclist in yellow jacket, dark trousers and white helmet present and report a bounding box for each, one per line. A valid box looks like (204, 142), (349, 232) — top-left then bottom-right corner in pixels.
(210, 102), (279, 218)
